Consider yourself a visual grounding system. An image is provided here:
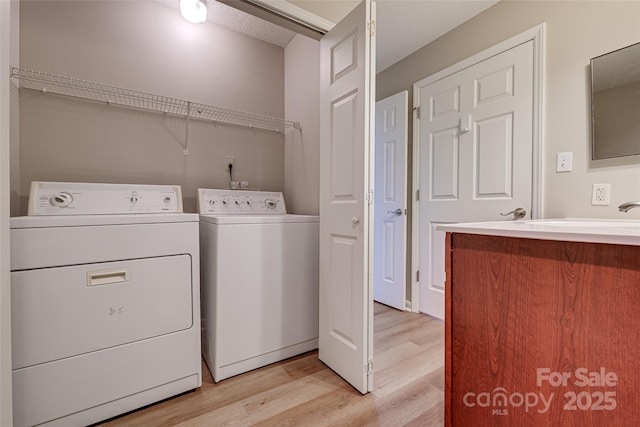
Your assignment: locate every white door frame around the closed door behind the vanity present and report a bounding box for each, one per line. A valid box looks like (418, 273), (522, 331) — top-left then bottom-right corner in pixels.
(411, 23), (546, 312)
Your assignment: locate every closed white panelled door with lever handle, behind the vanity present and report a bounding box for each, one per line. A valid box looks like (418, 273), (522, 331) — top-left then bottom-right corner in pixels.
(418, 41), (534, 318)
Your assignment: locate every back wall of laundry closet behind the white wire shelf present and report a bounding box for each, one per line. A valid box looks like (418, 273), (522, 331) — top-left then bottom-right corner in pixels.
(20, 0), (284, 213)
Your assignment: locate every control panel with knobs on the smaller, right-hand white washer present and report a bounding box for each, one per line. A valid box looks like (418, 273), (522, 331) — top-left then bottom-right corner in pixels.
(198, 188), (287, 215)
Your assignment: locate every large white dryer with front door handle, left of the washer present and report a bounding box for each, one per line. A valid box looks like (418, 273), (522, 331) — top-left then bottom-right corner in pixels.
(10, 182), (202, 427)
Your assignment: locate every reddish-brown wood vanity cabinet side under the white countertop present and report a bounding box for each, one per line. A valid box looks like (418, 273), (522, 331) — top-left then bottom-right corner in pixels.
(445, 232), (640, 427)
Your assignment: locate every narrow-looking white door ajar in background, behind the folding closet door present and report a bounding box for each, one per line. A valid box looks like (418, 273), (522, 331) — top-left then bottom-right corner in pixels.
(373, 90), (409, 310)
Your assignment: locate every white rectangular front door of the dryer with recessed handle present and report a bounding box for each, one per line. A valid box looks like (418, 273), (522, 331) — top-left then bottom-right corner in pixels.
(11, 255), (193, 370)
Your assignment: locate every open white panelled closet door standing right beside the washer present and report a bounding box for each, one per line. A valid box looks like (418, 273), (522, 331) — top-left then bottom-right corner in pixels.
(318, 0), (375, 393)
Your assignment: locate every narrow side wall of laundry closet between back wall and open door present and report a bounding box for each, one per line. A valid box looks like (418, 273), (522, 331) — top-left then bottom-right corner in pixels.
(284, 35), (320, 215)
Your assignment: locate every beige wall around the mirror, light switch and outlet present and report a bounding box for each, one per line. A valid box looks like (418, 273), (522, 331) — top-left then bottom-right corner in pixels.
(376, 1), (640, 219)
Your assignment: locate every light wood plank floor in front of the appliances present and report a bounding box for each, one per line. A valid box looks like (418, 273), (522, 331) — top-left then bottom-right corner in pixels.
(100, 303), (444, 427)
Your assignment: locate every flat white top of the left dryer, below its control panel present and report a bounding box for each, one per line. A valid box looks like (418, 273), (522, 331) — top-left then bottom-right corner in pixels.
(9, 213), (198, 229)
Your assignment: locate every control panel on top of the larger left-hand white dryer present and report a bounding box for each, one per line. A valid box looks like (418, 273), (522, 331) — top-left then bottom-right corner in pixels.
(29, 181), (182, 215)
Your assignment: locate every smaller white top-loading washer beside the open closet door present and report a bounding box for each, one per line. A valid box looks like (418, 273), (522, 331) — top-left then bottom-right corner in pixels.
(198, 189), (318, 382)
